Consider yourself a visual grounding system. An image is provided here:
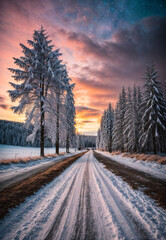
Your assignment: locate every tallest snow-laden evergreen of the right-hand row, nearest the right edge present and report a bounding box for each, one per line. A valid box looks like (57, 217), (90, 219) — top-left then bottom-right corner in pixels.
(140, 64), (166, 154)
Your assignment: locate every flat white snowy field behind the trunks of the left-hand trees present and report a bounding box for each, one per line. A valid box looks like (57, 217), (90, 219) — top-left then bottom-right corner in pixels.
(0, 144), (75, 160)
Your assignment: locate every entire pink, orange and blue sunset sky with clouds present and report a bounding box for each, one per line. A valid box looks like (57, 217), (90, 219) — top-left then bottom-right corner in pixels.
(0, 0), (166, 135)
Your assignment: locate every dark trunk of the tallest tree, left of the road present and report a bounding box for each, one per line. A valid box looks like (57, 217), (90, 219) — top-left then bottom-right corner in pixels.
(40, 77), (44, 157)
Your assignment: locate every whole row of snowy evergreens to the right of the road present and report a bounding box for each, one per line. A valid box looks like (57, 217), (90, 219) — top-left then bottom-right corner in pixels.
(96, 64), (166, 154)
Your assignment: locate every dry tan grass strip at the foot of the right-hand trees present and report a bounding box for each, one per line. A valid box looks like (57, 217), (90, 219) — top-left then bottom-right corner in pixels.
(122, 153), (166, 165)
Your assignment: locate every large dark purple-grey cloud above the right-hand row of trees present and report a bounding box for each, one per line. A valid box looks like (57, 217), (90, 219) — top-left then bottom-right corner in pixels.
(68, 17), (166, 92)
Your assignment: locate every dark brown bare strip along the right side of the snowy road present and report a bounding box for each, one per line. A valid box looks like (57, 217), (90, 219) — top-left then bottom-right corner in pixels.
(94, 151), (166, 209)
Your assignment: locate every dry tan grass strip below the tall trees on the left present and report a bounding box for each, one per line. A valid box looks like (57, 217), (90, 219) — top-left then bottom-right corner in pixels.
(0, 152), (65, 165)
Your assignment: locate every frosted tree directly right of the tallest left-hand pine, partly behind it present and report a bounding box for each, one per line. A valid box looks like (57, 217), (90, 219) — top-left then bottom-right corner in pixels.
(46, 61), (75, 154)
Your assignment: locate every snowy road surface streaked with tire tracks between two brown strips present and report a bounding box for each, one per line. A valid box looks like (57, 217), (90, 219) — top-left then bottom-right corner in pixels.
(0, 151), (166, 240)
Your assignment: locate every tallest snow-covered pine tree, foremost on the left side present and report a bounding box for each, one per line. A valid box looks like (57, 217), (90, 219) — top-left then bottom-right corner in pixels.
(8, 27), (58, 156)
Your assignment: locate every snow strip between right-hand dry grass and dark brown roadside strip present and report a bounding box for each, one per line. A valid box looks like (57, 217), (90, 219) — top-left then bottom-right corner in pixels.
(96, 151), (166, 180)
